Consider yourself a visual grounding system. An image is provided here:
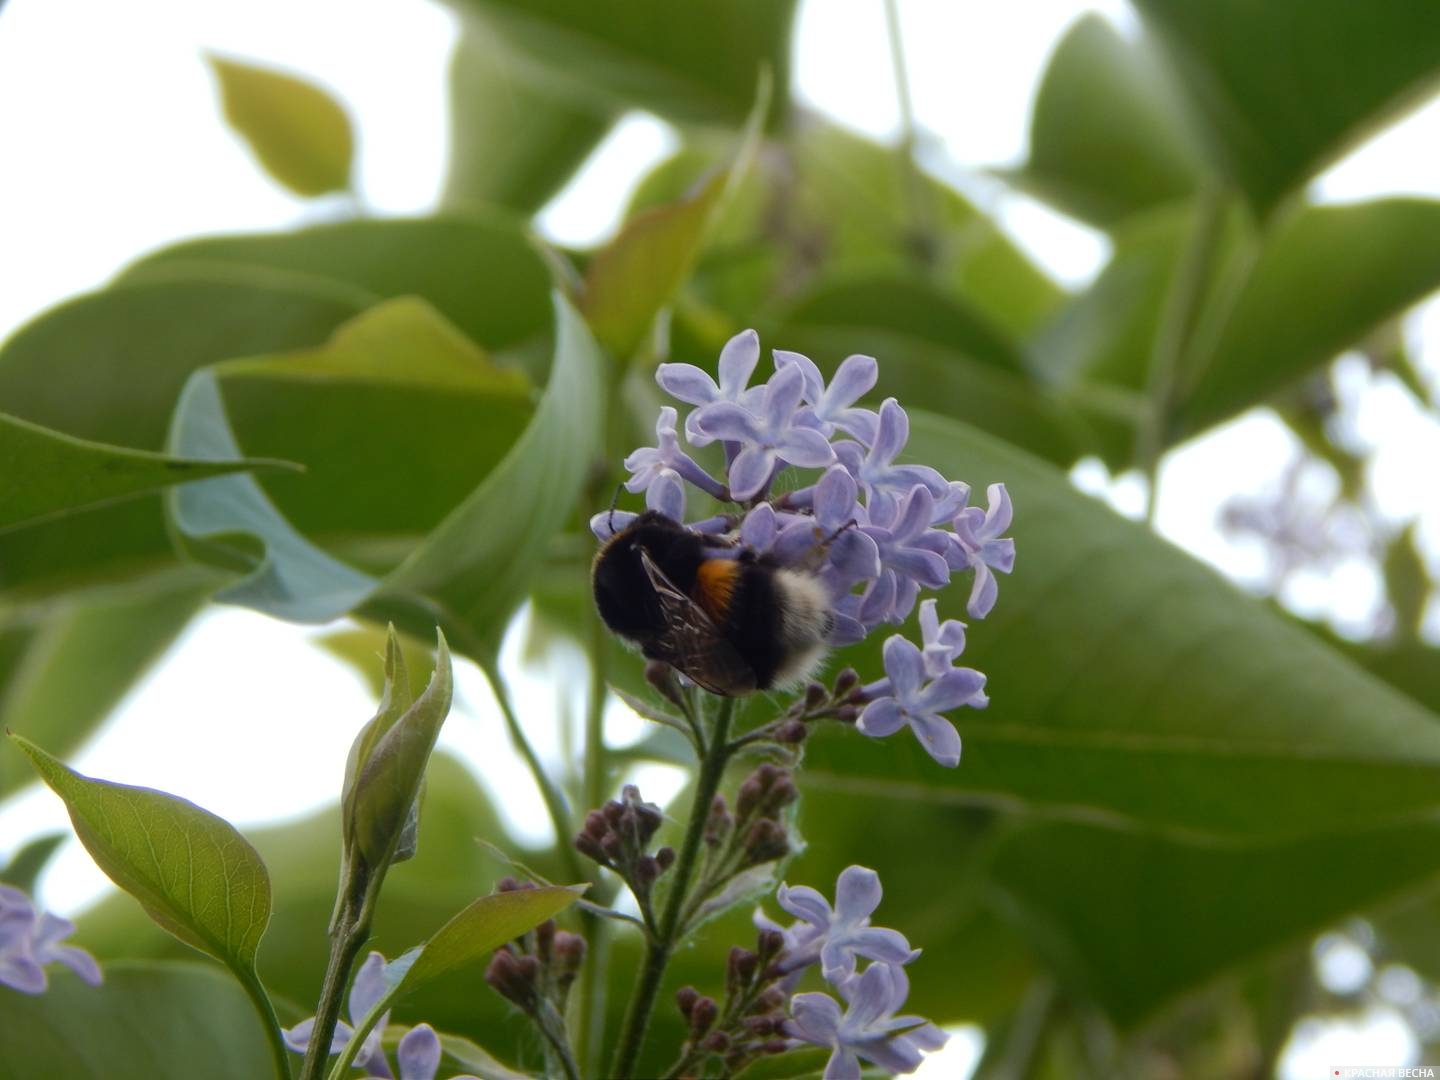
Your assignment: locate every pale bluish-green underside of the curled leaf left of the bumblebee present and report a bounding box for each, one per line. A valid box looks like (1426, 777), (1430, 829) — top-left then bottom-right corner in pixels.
(171, 289), (603, 654)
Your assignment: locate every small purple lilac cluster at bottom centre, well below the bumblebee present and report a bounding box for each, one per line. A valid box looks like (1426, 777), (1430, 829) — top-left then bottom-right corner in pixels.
(755, 867), (948, 1080)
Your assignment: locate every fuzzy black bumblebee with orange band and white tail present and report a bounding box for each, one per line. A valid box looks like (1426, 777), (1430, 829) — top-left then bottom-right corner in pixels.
(590, 510), (834, 697)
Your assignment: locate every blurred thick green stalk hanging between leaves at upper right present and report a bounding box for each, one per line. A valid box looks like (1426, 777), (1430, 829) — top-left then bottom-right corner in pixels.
(1136, 186), (1225, 524)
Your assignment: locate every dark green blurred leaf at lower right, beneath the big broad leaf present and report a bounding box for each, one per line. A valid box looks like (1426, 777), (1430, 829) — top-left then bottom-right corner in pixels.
(991, 817), (1440, 1027)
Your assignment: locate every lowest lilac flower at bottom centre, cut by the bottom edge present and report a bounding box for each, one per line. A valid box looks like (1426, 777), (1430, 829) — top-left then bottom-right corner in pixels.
(785, 963), (948, 1080)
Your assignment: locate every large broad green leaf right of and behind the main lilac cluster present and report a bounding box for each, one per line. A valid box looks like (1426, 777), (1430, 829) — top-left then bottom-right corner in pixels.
(806, 413), (1440, 840)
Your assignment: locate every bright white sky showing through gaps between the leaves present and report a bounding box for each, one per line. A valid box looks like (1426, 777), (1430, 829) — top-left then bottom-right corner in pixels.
(0, 0), (1440, 1077)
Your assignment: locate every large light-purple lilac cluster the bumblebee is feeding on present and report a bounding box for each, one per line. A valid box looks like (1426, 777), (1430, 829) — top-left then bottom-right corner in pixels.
(590, 330), (1015, 766)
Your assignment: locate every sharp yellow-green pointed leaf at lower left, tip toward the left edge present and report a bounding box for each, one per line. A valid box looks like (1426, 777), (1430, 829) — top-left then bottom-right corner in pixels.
(10, 734), (271, 981)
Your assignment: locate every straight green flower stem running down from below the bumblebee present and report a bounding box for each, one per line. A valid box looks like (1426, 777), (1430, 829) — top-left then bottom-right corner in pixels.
(609, 697), (734, 1080)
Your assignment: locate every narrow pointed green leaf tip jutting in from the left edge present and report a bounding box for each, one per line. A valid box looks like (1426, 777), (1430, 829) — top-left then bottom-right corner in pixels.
(0, 413), (297, 533)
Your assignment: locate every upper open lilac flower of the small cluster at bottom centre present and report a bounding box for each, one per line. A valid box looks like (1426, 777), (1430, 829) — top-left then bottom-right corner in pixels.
(775, 867), (920, 982)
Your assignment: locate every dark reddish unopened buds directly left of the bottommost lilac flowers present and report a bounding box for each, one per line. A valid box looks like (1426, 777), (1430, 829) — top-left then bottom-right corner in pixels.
(670, 930), (793, 1077)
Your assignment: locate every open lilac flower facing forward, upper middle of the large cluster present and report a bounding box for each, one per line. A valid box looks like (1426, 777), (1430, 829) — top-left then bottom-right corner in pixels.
(694, 366), (835, 503)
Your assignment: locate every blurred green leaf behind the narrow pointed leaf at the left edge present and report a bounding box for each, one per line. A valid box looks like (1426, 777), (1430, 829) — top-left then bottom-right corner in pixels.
(0, 275), (372, 598)
